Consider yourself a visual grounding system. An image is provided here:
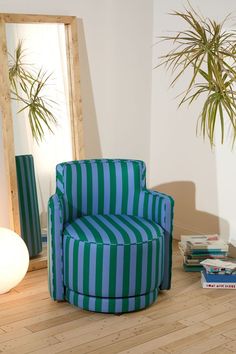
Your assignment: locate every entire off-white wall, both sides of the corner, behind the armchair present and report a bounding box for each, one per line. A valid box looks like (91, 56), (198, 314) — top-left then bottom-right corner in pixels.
(0, 0), (236, 242)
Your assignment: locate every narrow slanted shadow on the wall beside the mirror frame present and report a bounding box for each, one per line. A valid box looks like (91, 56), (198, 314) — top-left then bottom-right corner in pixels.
(78, 19), (102, 159)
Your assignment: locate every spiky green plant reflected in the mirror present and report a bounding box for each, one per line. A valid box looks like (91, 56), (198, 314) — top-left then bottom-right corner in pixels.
(8, 41), (57, 143)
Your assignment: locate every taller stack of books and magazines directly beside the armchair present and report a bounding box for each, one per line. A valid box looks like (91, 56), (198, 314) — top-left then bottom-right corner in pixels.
(179, 235), (229, 272)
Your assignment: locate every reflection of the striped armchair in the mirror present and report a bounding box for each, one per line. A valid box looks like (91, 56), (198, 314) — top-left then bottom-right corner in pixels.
(16, 155), (42, 257)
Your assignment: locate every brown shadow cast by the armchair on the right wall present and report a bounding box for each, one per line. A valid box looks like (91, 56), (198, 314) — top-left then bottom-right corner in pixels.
(152, 181), (229, 239)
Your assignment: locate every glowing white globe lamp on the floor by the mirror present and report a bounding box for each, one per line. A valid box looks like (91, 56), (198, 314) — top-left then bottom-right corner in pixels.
(0, 227), (29, 294)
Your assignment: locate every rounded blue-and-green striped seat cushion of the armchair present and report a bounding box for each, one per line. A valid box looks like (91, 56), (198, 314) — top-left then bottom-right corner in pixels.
(63, 215), (164, 298)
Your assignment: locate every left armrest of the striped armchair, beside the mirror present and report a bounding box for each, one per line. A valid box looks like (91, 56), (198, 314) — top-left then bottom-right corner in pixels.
(48, 194), (64, 300)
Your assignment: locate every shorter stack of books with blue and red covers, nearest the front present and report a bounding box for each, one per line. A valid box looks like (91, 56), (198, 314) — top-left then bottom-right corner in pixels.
(201, 259), (236, 289)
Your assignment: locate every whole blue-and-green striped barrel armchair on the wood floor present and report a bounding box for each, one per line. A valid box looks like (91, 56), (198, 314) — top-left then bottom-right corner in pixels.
(48, 159), (174, 313)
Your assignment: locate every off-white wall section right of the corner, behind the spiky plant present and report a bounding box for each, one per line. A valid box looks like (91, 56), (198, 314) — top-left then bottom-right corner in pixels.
(150, 0), (236, 239)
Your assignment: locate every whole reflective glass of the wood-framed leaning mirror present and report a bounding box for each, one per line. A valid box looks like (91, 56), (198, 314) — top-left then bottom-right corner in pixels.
(6, 24), (73, 264)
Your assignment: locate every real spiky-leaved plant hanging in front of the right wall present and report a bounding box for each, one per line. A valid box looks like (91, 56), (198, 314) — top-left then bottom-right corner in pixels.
(158, 4), (236, 146)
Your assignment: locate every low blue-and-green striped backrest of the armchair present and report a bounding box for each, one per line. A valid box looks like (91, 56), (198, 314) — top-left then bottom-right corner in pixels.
(56, 159), (146, 221)
